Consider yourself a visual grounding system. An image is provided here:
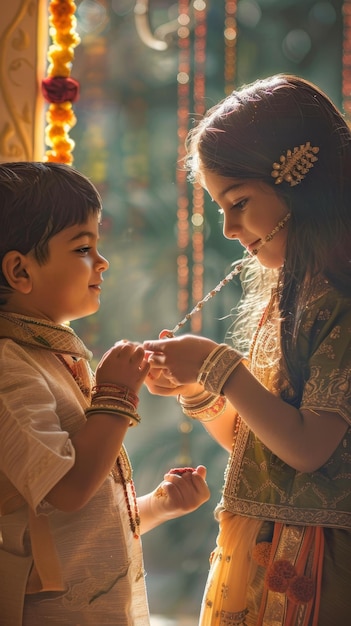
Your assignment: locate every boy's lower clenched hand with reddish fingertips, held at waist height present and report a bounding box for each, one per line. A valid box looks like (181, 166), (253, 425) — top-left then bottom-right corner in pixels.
(150, 465), (210, 521)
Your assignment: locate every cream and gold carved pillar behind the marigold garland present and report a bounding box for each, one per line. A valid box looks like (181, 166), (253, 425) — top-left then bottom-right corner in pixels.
(0, 0), (48, 162)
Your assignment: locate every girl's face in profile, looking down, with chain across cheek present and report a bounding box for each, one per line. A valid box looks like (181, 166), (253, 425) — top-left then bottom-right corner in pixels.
(202, 170), (289, 269)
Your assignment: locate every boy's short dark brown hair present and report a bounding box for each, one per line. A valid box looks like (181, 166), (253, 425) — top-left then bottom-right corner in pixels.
(0, 161), (102, 302)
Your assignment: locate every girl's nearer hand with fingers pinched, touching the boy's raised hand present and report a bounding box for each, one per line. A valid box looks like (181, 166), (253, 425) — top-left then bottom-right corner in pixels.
(143, 335), (217, 382)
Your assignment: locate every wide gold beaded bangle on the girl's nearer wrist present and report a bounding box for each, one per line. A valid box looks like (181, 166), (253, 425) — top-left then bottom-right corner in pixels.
(197, 343), (244, 395)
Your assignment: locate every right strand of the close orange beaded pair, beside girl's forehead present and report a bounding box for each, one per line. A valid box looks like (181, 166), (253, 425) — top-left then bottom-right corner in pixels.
(191, 0), (207, 333)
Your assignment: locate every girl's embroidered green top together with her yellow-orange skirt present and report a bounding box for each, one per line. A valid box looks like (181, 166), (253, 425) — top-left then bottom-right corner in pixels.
(200, 281), (351, 626)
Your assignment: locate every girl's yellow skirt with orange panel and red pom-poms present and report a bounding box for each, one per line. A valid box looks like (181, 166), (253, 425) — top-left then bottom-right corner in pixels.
(199, 511), (351, 626)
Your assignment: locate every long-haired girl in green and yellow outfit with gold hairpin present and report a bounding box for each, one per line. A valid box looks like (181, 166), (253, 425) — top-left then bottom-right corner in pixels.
(144, 75), (351, 626)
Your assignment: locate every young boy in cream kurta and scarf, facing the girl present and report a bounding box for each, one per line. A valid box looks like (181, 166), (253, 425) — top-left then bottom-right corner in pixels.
(0, 162), (209, 626)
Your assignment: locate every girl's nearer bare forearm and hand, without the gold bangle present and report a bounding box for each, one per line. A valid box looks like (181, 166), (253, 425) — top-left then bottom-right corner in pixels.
(144, 335), (348, 472)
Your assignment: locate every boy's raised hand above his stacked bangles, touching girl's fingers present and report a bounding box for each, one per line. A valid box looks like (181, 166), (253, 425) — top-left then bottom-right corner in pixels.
(95, 339), (150, 393)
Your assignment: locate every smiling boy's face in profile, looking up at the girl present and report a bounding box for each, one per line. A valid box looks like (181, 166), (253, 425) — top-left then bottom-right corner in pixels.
(26, 215), (109, 324)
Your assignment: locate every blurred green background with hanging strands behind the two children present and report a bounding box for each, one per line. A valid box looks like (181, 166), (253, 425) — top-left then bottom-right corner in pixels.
(71, 0), (351, 626)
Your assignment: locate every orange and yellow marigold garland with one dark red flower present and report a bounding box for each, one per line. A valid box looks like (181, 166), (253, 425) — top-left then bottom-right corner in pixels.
(42, 0), (80, 165)
